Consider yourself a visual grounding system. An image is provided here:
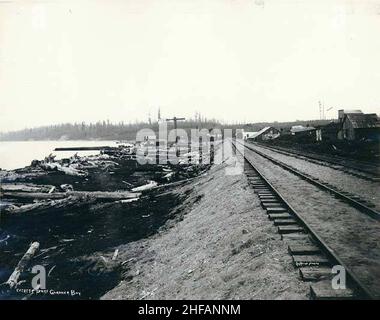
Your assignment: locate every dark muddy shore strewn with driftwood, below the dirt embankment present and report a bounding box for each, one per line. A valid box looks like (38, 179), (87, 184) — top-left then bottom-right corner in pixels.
(0, 145), (208, 299)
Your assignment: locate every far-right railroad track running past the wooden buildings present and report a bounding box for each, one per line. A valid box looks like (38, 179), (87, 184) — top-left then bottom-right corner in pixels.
(252, 143), (380, 182)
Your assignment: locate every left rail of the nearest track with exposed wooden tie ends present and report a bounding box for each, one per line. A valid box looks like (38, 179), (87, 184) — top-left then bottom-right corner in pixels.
(232, 142), (379, 299)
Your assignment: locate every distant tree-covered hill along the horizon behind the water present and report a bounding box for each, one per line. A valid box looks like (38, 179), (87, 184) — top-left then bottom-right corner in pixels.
(0, 119), (331, 141)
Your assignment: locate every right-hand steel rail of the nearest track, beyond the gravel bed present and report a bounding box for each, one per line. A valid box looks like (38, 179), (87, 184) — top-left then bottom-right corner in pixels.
(239, 142), (380, 220)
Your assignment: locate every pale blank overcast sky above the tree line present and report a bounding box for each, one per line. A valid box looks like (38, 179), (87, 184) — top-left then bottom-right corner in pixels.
(0, 0), (380, 131)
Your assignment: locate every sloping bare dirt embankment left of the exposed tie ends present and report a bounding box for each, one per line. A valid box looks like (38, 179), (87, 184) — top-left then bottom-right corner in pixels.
(102, 150), (308, 299)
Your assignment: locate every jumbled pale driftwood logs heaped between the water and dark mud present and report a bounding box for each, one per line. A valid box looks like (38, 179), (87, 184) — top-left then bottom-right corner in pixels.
(0, 141), (214, 214)
